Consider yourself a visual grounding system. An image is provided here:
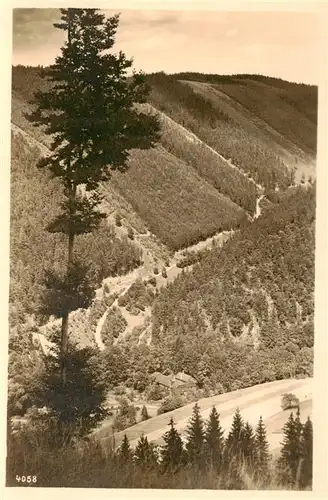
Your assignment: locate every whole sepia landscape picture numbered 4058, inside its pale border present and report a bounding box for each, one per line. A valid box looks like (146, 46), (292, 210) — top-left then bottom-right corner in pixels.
(4, 2), (326, 491)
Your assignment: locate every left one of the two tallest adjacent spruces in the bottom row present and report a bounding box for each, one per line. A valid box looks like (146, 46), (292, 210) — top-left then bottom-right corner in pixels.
(186, 403), (205, 468)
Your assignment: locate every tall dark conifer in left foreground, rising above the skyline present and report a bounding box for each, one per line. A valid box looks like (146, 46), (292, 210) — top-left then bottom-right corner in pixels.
(28, 9), (159, 386)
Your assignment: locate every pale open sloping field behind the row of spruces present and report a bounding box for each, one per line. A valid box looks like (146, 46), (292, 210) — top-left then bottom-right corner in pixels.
(95, 378), (312, 449)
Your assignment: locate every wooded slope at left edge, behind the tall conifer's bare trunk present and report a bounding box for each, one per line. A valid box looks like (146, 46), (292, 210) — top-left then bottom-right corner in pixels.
(10, 134), (142, 325)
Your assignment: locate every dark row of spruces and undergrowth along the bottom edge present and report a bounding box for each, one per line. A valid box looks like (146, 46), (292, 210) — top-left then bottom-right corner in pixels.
(7, 403), (313, 490)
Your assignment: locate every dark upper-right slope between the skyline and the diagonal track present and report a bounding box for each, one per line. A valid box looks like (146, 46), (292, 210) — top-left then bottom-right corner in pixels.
(148, 73), (317, 189)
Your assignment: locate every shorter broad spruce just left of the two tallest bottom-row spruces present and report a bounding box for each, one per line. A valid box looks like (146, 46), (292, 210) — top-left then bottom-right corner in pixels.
(161, 417), (185, 472)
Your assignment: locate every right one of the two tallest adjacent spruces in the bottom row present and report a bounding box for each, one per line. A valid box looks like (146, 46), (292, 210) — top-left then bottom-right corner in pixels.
(205, 406), (224, 471)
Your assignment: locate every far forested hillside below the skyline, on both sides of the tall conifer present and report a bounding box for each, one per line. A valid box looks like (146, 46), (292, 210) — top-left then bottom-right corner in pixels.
(12, 66), (316, 254)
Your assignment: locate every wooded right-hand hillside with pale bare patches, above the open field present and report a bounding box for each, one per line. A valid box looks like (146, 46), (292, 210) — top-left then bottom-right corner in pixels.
(152, 186), (315, 390)
